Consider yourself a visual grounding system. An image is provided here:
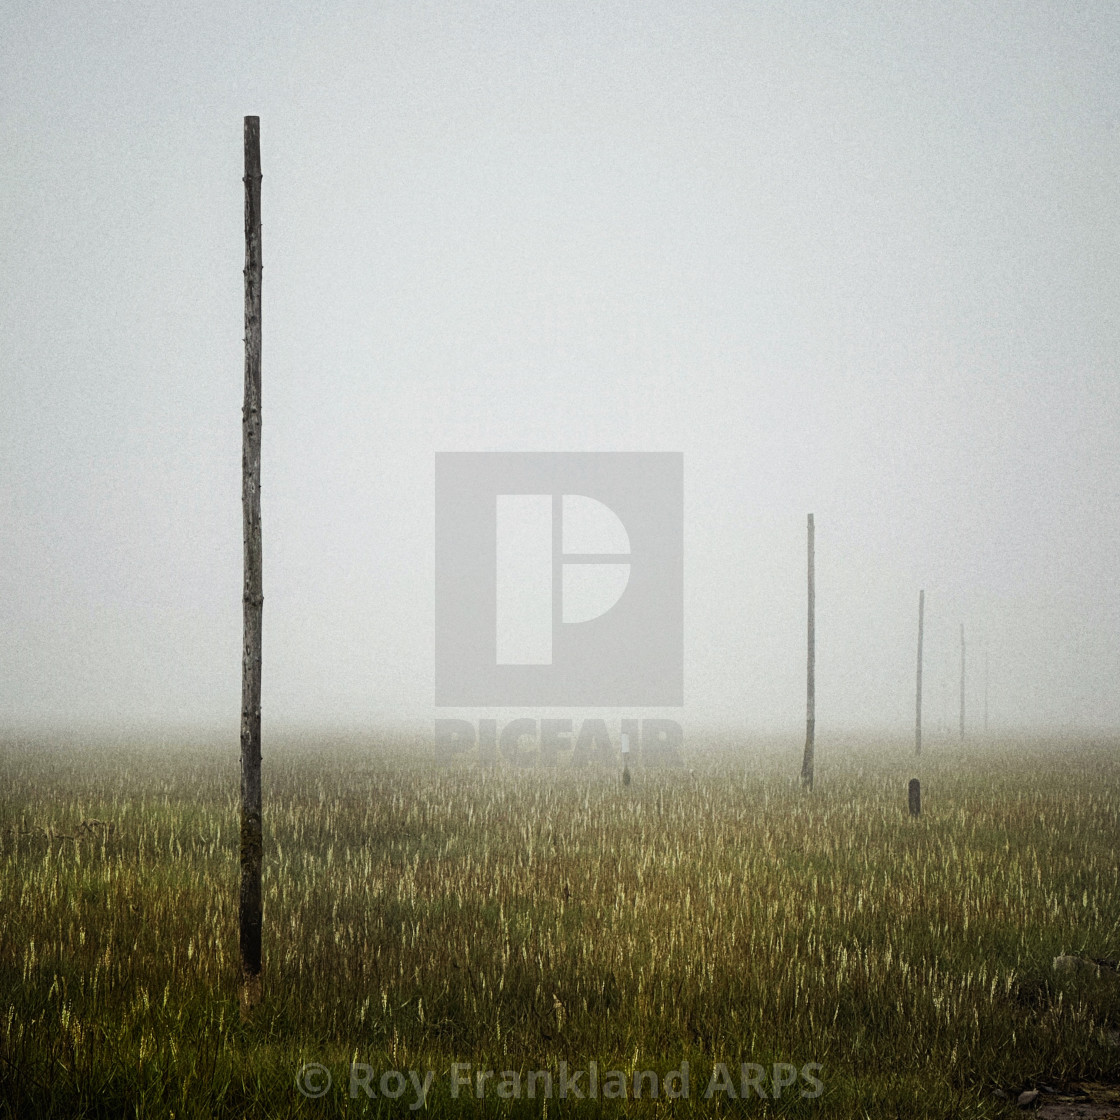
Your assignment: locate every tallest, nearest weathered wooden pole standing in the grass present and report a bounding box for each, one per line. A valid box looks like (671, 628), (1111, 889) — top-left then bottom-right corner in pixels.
(239, 116), (264, 1015)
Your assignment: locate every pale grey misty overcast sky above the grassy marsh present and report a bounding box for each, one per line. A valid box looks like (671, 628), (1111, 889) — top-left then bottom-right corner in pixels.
(0, 0), (1120, 735)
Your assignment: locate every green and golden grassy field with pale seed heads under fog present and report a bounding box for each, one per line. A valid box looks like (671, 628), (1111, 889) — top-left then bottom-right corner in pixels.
(0, 736), (1120, 1118)
